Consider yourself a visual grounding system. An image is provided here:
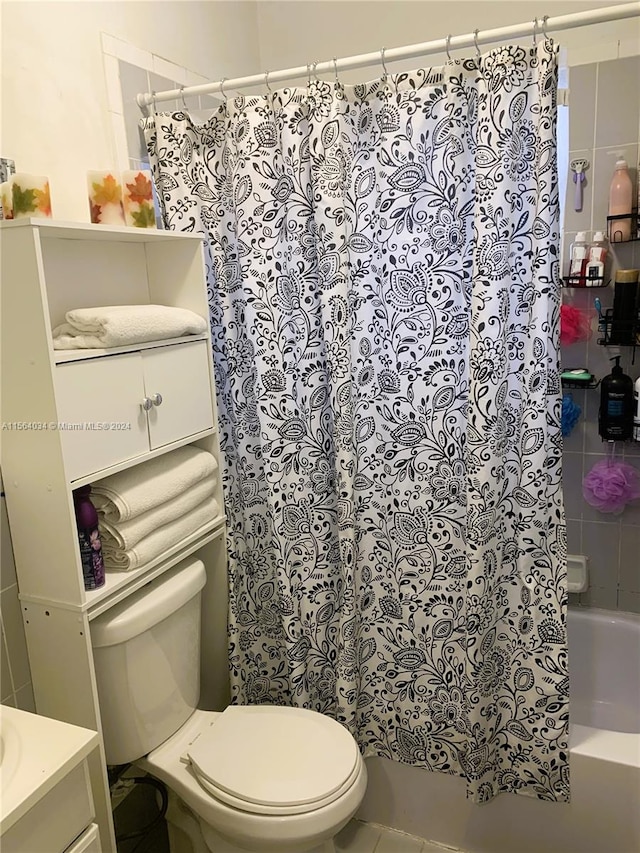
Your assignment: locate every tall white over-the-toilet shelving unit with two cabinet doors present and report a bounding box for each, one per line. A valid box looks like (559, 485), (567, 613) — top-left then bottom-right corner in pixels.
(0, 219), (228, 853)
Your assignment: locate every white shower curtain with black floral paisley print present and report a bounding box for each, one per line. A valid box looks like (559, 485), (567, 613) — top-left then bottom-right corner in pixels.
(143, 41), (568, 802)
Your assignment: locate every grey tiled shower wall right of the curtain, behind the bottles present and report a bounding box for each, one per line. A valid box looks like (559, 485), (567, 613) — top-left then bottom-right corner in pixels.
(562, 56), (640, 613)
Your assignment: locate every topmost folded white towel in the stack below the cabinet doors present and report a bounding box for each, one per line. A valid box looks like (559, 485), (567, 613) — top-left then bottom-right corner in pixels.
(91, 445), (218, 524)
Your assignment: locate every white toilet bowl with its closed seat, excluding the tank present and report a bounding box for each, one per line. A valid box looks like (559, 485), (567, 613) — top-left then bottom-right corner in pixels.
(136, 706), (367, 853)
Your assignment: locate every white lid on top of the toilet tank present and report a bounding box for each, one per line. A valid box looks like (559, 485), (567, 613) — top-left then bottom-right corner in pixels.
(91, 560), (207, 648)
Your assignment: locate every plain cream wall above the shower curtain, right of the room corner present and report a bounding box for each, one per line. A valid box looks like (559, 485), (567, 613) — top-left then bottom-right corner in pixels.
(258, 0), (640, 75)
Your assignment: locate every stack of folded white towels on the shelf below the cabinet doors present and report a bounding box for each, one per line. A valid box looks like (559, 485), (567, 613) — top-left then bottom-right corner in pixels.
(91, 446), (220, 571)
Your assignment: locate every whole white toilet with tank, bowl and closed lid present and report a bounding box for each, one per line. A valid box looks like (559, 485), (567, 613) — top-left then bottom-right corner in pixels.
(91, 560), (367, 853)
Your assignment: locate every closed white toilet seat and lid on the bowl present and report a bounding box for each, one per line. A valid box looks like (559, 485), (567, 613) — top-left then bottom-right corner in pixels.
(186, 705), (362, 815)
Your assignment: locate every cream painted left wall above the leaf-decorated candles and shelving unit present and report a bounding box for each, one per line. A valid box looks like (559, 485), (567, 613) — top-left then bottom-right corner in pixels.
(0, 0), (260, 222)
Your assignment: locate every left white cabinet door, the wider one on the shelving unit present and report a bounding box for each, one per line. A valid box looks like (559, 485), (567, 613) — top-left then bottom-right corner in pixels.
(55, 352), (149, 480)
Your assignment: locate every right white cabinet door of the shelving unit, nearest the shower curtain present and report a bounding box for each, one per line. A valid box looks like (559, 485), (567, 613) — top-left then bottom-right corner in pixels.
(141, 341), (213, 450)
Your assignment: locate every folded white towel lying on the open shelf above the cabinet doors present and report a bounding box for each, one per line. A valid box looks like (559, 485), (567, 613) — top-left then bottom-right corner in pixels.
(53, 305), (207, 349)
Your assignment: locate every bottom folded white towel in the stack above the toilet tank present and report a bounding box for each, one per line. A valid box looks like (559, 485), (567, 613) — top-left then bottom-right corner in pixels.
(100, 498), (220, 572)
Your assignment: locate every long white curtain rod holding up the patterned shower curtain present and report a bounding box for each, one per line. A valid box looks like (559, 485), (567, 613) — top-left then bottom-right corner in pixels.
(136, 2), (640, 112)
